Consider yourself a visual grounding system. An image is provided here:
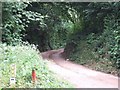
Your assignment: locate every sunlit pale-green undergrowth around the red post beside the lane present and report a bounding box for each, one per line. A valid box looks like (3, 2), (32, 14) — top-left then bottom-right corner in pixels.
(0, 43), (72, 88)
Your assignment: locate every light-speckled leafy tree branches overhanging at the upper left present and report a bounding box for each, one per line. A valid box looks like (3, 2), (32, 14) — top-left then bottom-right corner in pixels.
(2, 2), (44, 45)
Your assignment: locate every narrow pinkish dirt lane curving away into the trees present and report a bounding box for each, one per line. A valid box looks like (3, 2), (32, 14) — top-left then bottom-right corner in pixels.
(42, 49), (119, 88)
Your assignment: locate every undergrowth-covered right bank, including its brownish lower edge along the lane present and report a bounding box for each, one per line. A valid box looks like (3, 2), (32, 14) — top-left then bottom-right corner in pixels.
(70, 16), (120, 76)
